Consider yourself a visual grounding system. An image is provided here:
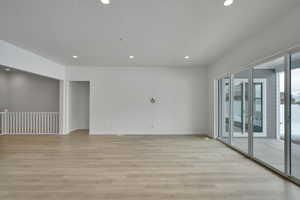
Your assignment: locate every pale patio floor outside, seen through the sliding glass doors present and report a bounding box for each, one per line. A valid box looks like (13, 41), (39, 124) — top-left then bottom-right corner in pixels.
(232, 138), (300, 178)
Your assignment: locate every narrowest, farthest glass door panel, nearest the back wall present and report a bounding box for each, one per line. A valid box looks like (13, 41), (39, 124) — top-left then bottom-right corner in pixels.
(218, 77), (230, 143)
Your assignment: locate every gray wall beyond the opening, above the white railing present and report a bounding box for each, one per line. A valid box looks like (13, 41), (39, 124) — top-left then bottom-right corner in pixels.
(0, 66), (59, 112)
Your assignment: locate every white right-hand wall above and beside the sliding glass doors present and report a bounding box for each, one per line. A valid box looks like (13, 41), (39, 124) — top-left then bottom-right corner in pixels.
(208, 7), (300, 136)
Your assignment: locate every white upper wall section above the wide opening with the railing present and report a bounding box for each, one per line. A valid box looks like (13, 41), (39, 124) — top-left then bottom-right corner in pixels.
(0, 40), (65, 80)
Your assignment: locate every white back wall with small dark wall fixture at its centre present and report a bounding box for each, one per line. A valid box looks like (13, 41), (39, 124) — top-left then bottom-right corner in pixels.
(67, 66), (208, 134)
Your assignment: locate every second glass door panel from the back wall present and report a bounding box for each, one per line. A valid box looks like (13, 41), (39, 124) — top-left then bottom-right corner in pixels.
(232, 70), (250, 153)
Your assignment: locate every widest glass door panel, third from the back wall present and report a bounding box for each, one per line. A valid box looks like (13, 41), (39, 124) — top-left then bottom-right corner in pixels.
(252, 57), (285, 171)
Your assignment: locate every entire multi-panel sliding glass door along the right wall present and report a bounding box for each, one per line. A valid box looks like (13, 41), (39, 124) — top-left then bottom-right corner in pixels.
(218, 51), (300, 183)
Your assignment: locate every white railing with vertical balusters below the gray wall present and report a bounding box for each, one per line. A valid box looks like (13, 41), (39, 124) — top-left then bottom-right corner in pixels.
(0, 112), (59, 134)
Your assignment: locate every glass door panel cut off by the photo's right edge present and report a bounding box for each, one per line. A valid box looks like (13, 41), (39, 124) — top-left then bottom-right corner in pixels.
(291, 52), (300, 179)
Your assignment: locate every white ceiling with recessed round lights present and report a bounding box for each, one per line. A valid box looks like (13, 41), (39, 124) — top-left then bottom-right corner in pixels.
(0, 0), (300, 67)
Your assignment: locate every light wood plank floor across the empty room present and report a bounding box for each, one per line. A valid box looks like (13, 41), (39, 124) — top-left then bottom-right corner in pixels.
(0, 132), (300, 200)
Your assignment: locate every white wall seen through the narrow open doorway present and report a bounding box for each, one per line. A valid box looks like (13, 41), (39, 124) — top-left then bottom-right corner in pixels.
(69, 81), (90, 132)
